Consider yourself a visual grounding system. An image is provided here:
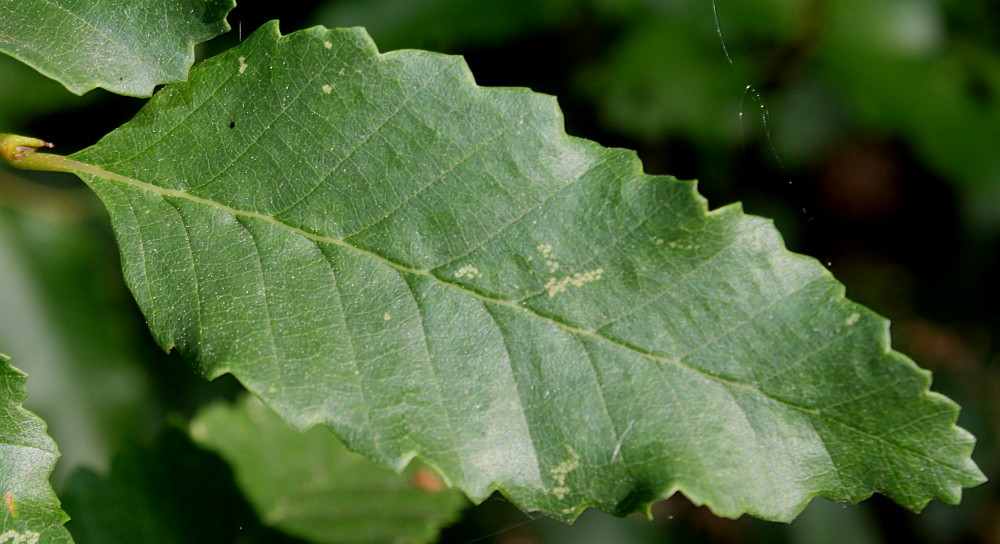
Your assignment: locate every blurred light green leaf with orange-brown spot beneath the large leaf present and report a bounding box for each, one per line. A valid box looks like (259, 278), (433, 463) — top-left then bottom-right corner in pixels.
(191, 398), (466, 544)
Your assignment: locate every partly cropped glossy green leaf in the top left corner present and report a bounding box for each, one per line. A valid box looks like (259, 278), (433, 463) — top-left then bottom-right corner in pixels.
(0, 0), (236, 96)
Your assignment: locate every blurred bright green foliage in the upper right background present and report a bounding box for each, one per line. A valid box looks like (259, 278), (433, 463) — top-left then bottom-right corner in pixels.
(324, 0), (1000, 229)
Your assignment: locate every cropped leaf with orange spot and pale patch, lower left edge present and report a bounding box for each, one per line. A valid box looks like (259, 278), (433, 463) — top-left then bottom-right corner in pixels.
(0, 354), (73, 544)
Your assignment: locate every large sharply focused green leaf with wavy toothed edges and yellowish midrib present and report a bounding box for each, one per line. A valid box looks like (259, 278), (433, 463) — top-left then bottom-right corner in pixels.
(54, 24), (983, 520)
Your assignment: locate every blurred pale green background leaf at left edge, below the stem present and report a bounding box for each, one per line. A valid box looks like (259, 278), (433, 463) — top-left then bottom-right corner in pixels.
(0, 180), (162, 484)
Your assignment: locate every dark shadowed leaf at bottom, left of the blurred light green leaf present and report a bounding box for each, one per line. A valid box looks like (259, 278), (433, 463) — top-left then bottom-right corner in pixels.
(64, 429), (299, 544)
